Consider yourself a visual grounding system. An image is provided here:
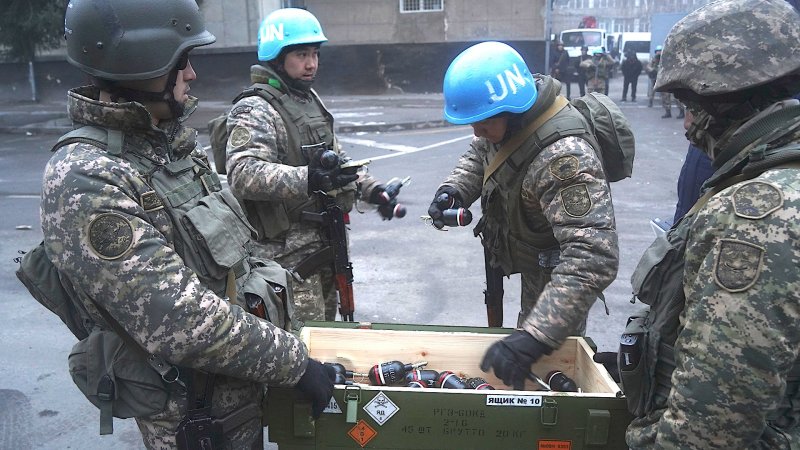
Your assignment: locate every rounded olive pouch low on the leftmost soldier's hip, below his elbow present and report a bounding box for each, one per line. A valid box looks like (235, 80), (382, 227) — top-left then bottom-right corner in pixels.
(69, 328), (170, 434)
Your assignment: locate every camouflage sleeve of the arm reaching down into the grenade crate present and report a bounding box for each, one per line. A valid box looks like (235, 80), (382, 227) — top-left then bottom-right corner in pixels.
(521, 137), (619, 348)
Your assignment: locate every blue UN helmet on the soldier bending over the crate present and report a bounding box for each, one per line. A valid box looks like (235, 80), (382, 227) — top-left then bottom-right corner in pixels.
(442, 41), (538, 125)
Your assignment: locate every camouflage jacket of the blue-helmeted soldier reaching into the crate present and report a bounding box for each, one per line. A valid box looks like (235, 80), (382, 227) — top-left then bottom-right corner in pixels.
(442, 77), (619, 348)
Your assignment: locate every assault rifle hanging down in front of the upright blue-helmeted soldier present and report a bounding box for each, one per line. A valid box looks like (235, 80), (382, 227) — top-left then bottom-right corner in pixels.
(293, 146), (369, 322)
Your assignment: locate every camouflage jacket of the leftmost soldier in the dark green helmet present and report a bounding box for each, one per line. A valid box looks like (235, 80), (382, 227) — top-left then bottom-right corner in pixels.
(41, 87), (307, 442)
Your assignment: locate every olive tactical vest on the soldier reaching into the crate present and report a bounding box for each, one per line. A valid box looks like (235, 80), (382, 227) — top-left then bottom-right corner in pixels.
(475, 104), (600, 275)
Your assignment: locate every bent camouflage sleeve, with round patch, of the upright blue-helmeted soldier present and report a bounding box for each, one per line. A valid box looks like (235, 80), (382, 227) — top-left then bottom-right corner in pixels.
(226, 96), (308, 201)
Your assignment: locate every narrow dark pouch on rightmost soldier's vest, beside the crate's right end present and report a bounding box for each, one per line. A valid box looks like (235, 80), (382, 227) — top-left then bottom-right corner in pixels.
(617, 308), (651, 417)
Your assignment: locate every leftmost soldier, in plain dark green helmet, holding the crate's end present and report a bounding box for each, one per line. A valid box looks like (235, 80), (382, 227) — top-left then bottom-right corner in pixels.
(41, 0), (335, 449)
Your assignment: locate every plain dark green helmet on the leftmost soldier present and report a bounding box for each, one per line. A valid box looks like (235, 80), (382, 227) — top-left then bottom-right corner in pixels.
(64, 0), (216, 81)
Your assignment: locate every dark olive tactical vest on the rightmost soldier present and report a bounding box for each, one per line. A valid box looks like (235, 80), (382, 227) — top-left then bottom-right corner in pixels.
(618, 145), (800, 429)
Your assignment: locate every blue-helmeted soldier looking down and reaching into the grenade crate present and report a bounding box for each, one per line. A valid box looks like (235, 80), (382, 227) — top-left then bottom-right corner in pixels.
(428, 42), (619, 389)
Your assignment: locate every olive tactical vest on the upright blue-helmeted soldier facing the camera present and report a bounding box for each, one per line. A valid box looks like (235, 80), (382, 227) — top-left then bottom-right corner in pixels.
(233, 66), (355, 240)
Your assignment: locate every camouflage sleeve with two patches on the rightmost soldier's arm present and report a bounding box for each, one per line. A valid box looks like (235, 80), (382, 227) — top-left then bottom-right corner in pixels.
(656, 169), (800, 449)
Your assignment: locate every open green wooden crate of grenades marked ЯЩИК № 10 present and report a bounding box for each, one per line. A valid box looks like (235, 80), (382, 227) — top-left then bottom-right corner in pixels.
(267, 322), (632, 450)
